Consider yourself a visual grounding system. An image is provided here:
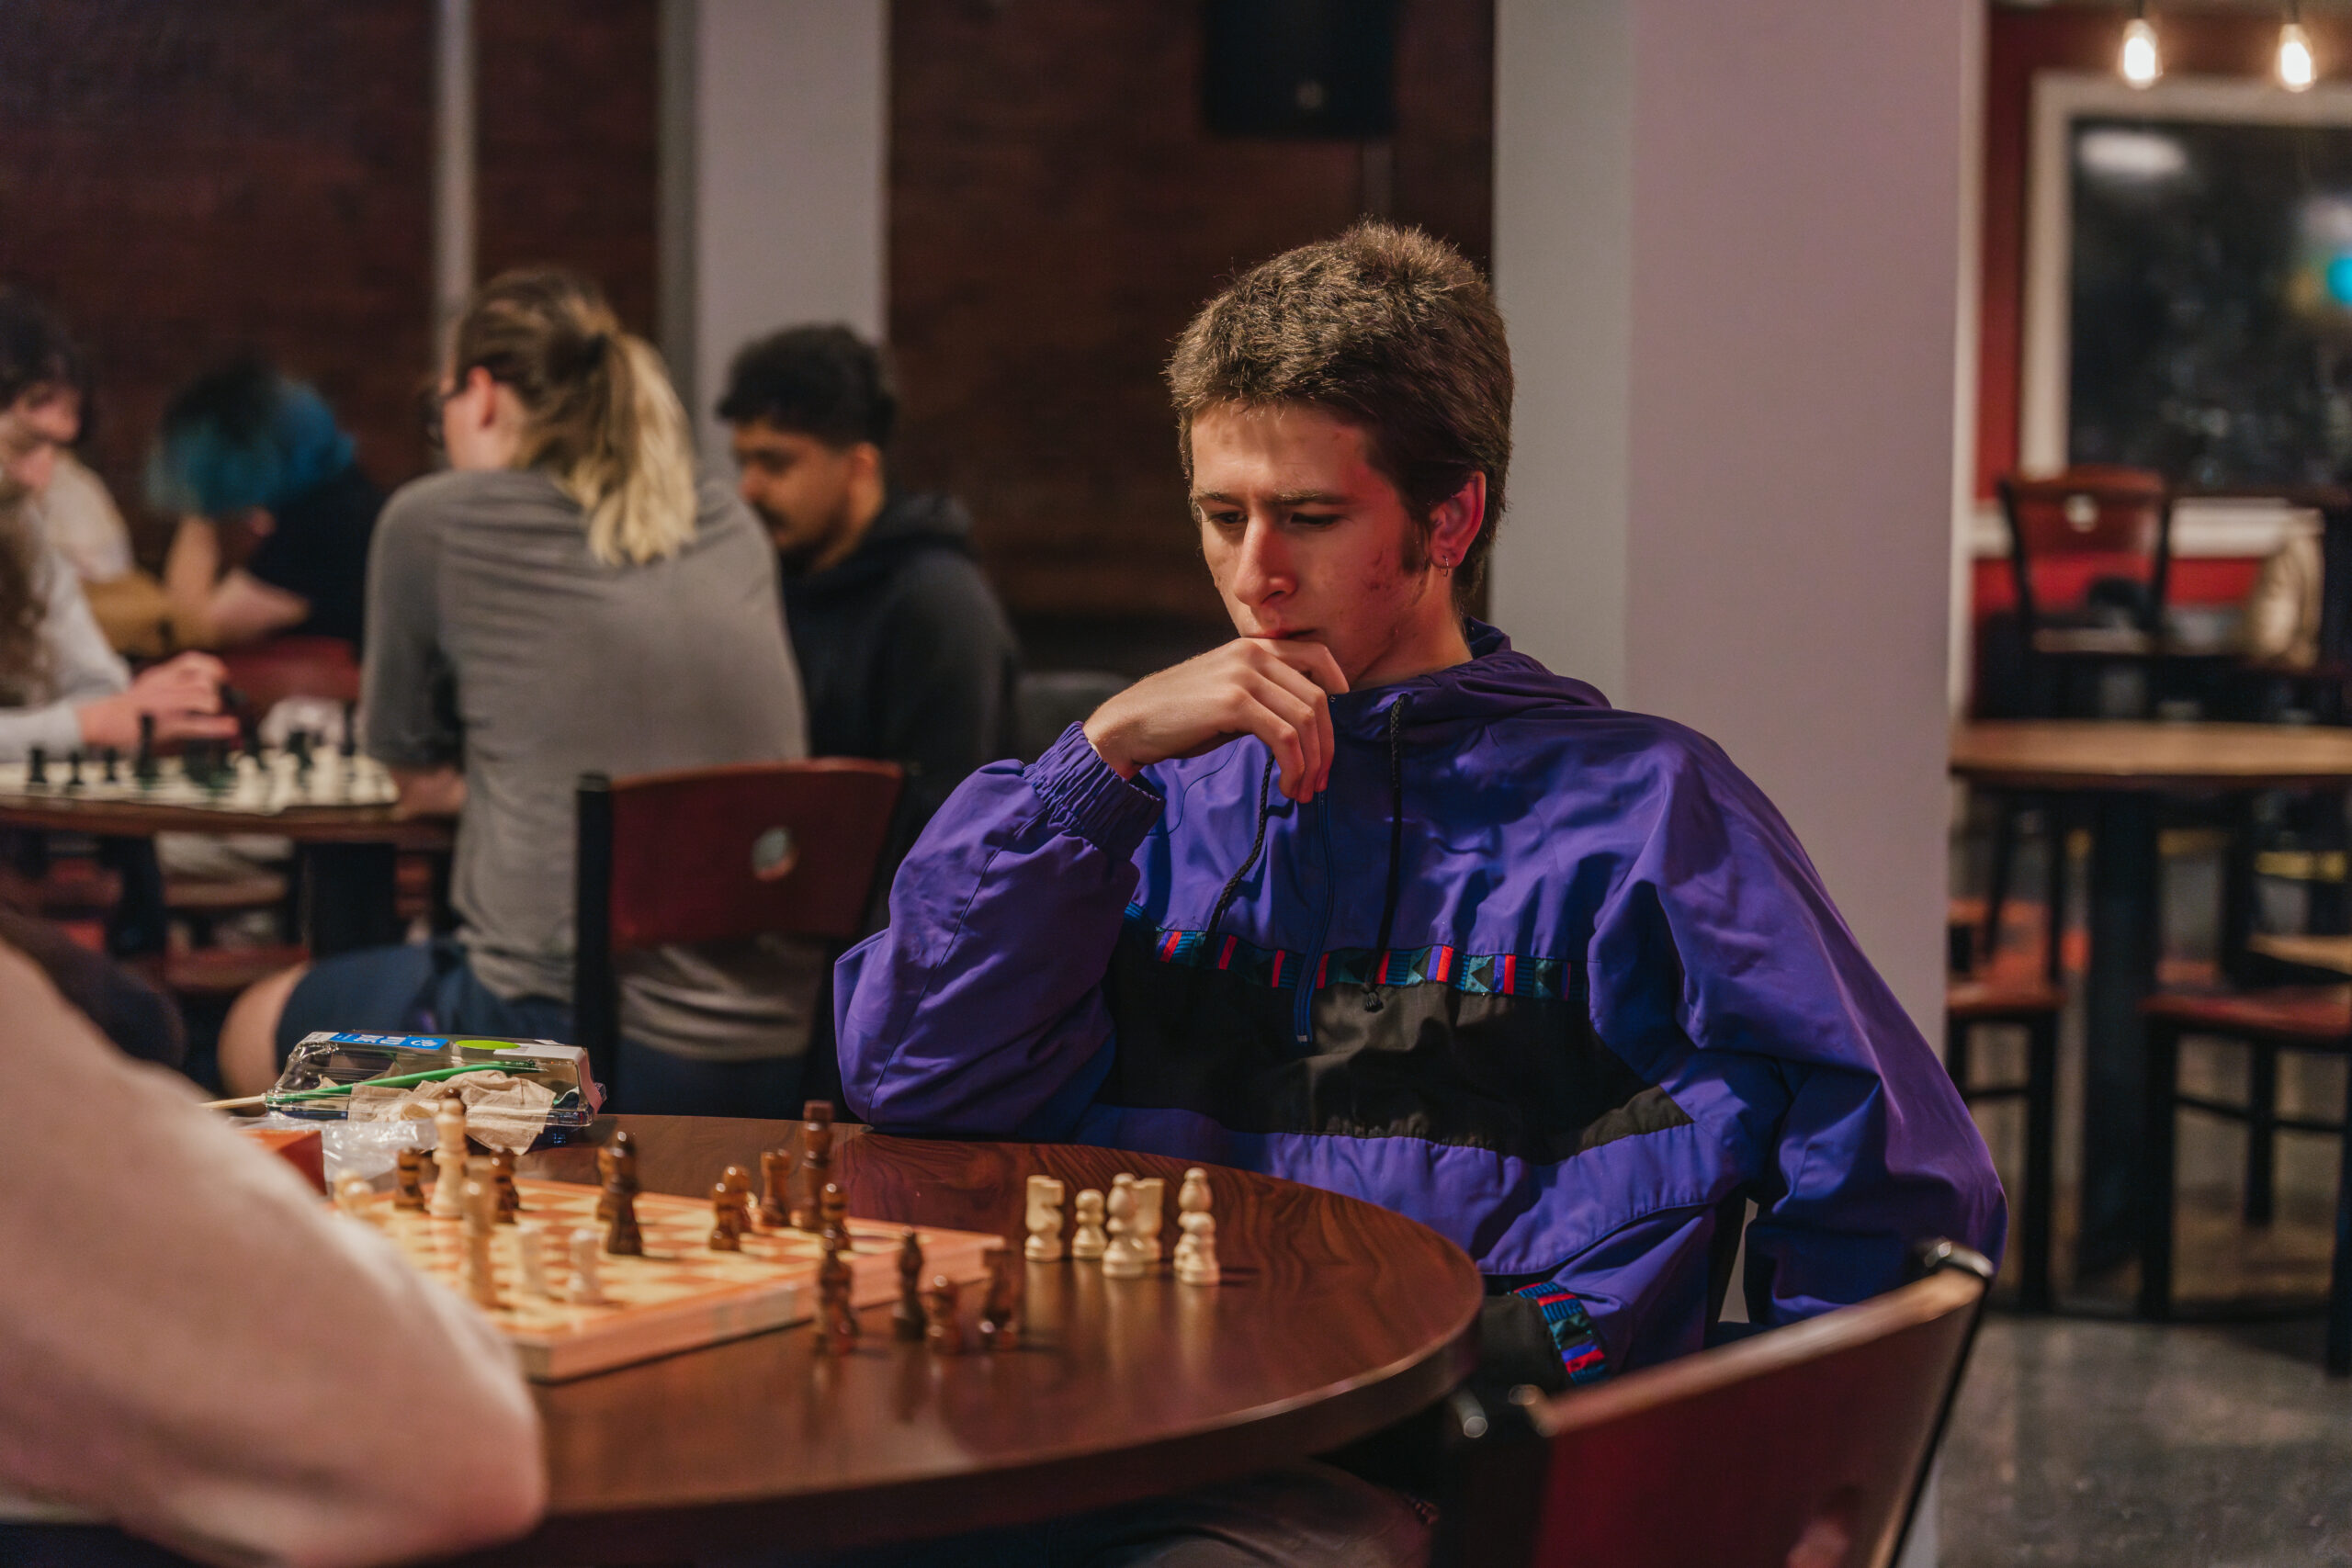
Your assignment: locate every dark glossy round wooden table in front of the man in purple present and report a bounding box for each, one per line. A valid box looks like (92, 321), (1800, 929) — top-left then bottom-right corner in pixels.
(458, 1117), (1484, 1563)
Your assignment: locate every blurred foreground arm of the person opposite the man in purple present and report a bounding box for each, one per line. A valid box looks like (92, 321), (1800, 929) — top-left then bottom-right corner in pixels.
(0, 950), (546, 1568)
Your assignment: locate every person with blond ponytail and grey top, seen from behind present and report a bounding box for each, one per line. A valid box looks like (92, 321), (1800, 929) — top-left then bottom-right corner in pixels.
(221, 273), (823, 1117)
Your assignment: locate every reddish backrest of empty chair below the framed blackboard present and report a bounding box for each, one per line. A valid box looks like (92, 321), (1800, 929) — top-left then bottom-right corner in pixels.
(1999, 463), (2173, 630)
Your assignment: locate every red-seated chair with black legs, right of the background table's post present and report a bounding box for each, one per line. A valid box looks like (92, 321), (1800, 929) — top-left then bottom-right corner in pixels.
(2141, 985), (2352, 1378)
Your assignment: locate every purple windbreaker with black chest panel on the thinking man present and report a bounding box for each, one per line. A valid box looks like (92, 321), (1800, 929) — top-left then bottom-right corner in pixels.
(835, 623), (2007, 1368)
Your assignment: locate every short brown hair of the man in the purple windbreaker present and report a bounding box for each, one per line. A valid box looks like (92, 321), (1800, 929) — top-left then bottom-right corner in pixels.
(1167, 223), (1512, 600)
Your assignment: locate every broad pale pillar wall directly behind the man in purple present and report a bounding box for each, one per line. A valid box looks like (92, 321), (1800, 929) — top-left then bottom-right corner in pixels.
(1494, 0), (1981, 1053)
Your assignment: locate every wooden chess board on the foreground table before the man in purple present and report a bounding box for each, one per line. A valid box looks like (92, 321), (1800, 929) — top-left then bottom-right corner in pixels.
(357, 1178), (1004, 1382)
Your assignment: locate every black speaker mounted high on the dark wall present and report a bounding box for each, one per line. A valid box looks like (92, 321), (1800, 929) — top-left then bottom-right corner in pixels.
(1202, 0), (1397, 141)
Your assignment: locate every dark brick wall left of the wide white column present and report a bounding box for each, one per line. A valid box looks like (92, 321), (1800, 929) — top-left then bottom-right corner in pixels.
(0, 0), (656, 559)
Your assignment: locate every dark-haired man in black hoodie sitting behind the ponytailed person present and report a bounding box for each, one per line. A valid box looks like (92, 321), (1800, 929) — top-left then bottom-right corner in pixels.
(718, 327), (1018, 888)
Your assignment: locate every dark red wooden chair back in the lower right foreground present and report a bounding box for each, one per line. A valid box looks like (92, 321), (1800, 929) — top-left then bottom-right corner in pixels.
(1446, 1244), (1992, 1568)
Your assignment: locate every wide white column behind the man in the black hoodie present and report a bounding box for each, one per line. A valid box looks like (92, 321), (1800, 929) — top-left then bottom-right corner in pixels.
(661, 0), (889, 458)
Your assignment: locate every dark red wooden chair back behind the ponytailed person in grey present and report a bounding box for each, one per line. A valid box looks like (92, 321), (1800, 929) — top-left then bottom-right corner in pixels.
(571, 757), (903, 1110)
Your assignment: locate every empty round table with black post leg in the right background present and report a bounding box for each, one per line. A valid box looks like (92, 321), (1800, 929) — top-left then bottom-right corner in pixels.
(1952, 719), (2352, 1267)
